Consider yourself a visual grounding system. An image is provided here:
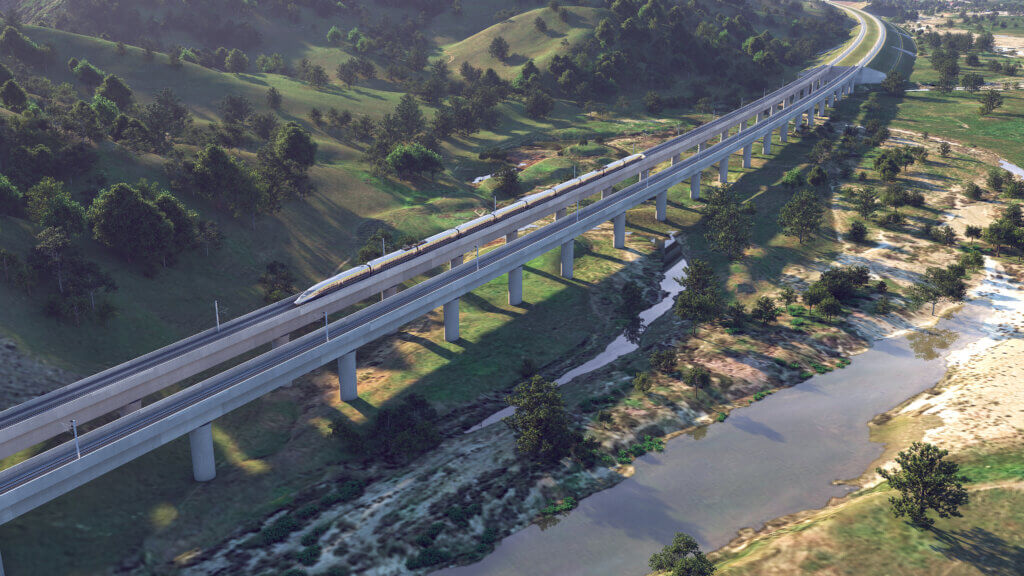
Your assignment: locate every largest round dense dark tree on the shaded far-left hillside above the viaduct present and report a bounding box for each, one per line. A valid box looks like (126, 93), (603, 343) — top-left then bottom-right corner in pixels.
(88, 183), (174, 265)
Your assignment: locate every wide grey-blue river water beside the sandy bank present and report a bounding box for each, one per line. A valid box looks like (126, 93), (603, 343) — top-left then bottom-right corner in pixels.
(435, 304), (990, 576)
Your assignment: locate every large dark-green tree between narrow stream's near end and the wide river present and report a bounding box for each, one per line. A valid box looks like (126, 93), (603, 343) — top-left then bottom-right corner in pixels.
(505, 376), (583, 463)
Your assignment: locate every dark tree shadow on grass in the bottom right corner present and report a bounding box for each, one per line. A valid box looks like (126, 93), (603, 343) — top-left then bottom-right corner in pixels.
(932, 526), (1024, 576)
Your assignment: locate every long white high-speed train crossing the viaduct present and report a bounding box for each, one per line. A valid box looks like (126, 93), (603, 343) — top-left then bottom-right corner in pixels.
(295, 154), (644, 305)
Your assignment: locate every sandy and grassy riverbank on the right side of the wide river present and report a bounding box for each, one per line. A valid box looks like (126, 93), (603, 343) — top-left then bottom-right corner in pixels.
(713, 256), (1024, 576)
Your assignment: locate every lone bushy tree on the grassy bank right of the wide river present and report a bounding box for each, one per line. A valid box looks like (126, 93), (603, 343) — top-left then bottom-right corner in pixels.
(876, 442), (968, 528)
